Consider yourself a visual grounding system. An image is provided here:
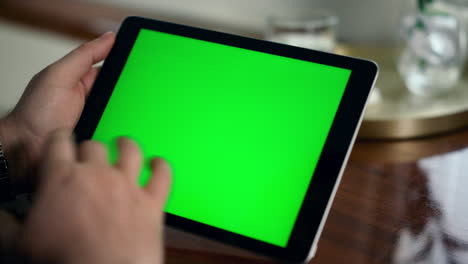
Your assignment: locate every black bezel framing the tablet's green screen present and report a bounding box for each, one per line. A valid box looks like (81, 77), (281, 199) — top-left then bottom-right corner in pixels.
(75, 17), (377, 263)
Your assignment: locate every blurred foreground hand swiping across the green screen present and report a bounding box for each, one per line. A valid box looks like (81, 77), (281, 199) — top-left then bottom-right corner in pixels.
(22, 132), (171, 264)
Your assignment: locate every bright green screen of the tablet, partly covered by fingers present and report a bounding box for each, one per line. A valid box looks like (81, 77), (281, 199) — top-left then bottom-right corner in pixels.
(93, 29), (351, 247)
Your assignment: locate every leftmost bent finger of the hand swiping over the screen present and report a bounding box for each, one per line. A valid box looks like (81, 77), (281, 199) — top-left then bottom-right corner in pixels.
(44, 130), (76, 164)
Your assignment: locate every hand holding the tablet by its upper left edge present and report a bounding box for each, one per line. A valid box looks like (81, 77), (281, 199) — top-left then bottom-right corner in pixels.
(0, 32), (115, 185)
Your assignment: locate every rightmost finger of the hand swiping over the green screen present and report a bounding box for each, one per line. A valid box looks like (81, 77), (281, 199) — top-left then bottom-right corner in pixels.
(145, 158), (172, 209)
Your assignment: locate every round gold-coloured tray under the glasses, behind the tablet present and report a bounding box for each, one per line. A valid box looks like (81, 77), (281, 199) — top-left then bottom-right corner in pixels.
(338, 46), (468, 139)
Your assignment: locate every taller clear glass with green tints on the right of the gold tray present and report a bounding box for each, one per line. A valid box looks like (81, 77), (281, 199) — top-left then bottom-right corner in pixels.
(398, 11), (467, 96)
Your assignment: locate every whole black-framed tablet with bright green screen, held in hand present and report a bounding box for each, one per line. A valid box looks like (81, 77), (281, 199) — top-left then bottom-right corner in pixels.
(75, 17), (377, 263)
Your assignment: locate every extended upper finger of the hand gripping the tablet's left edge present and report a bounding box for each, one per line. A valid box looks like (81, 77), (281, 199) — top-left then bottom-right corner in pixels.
(51, 32), (115, 84)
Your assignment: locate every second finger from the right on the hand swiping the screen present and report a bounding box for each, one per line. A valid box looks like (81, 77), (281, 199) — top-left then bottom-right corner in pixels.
(115, 137), (143, 183)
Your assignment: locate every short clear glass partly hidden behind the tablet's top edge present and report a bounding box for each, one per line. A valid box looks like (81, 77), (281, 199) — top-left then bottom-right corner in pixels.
(265, 10), (339, 52)
